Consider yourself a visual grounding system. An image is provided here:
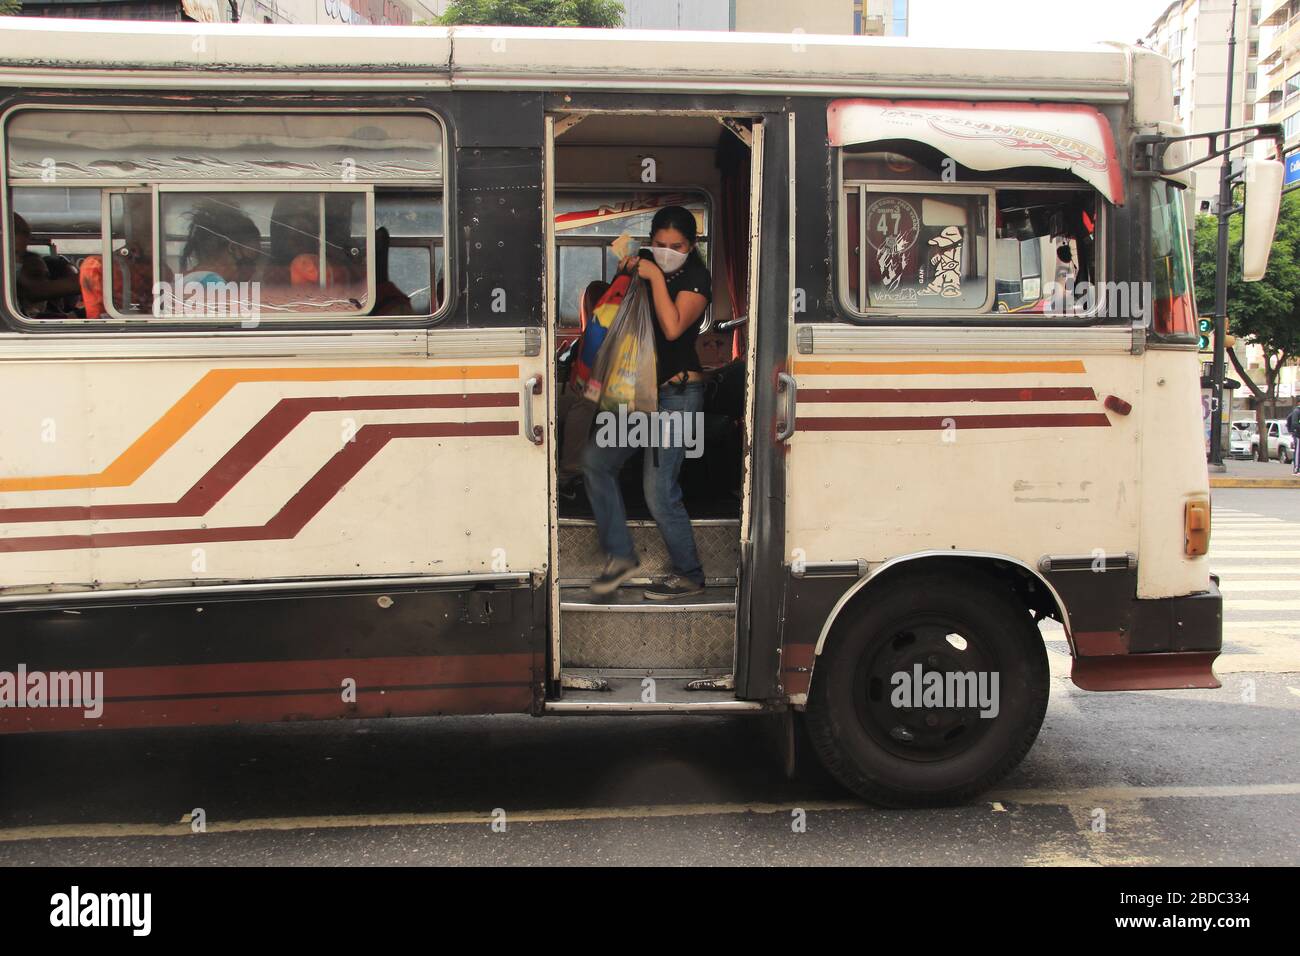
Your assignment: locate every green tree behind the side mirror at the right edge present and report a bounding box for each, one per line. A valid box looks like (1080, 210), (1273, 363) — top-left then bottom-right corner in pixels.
(1193, 193), (1300, 460)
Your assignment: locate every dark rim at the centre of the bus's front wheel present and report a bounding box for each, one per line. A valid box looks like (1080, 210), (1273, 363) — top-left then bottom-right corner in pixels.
(853, 614), (1001, 762)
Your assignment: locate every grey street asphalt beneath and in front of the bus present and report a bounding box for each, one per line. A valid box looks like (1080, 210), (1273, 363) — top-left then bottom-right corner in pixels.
(0, 489), (1300, 866)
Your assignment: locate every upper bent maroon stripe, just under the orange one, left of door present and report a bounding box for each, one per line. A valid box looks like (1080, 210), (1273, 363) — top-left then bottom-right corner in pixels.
(0, 392), (519, 523)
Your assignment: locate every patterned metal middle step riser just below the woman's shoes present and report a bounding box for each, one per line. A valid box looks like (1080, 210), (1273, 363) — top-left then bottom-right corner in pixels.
(560, 587), (736, 675)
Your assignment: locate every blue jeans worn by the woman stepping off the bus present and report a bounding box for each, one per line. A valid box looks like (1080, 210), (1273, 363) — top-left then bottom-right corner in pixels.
(582, 382), (705, 584)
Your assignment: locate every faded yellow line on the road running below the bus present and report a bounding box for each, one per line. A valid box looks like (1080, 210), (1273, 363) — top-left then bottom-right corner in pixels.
(0, 783), (1300, 843)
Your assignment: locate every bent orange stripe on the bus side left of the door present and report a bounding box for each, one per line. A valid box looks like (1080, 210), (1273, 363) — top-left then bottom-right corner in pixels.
(0, 365), (519, 492)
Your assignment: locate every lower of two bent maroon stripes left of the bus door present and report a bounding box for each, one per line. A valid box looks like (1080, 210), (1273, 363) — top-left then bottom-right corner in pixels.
(0, 421), (519, 551)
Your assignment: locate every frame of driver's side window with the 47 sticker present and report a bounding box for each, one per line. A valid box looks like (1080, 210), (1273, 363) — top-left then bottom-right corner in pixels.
(832, 144), (1107, 329)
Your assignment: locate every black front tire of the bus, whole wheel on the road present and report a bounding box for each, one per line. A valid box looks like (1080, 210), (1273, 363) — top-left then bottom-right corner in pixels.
(806, 575), (1050, 806)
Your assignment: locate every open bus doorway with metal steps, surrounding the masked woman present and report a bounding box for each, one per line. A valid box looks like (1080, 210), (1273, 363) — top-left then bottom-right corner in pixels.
(551, 113), (755, 709)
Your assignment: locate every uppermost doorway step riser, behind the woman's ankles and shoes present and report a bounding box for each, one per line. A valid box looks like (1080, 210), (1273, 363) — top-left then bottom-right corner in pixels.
(559, 518), (740, 585)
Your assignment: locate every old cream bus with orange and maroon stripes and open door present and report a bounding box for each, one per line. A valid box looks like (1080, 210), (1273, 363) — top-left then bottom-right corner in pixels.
(0, 18), (1281, 805)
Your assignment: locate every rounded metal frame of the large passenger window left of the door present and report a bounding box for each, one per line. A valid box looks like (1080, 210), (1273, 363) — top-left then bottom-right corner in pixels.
(0, 100), (458, 334)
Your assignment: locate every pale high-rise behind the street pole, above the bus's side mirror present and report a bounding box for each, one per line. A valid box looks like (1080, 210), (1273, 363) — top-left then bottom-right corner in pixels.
(1141, 0), (1270, 212)
